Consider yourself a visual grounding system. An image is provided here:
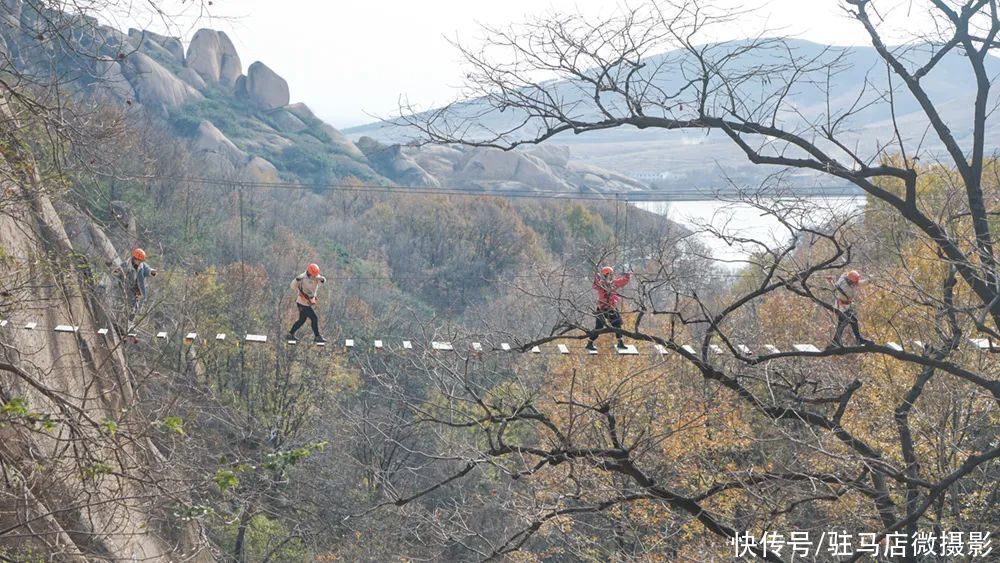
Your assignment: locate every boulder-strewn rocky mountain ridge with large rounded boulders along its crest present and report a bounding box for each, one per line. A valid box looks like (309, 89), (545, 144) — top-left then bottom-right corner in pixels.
(0, 0), (647, 193)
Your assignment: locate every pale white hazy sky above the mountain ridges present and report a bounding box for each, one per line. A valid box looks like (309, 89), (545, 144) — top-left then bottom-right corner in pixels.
(144, 0), (916, 128)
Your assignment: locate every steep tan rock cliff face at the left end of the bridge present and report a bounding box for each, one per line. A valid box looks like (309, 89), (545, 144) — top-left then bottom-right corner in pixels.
(0, 100), (206, 561)
